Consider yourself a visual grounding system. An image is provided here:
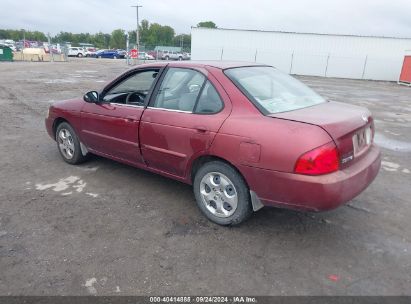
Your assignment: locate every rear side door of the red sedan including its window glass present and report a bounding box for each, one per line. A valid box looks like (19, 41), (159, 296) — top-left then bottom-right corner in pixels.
(140, 67), (231, 178)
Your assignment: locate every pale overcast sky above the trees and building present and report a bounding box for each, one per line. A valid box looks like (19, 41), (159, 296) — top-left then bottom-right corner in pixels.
(0, 0), (411, 38)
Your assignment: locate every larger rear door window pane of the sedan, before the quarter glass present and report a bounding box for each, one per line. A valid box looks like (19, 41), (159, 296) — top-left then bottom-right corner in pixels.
(153, 68), (205, 112)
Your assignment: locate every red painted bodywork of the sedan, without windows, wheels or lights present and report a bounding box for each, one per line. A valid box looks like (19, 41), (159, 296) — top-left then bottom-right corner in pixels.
(46, 62), (381, 210)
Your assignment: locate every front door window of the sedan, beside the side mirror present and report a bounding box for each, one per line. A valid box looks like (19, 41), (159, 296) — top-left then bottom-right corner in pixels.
(103, 70), (158, 105)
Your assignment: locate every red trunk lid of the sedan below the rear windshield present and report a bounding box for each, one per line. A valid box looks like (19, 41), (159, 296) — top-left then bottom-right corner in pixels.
(269, 101), (374, 167)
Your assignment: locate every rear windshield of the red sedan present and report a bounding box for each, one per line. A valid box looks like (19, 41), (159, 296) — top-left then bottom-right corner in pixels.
(224, 67), (326, 115)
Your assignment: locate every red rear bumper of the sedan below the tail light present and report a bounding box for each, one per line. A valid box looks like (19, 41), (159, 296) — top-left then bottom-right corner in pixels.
(241, 145), (381, 211)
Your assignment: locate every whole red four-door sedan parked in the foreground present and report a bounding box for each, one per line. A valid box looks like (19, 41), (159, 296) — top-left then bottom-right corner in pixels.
(46, 62), (381, 225)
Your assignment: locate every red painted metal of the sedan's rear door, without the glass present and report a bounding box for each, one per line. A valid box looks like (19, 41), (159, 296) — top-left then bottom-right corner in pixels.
(140, 65), (232, 179)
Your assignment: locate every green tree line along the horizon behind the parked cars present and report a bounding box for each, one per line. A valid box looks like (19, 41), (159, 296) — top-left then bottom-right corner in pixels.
(0, 20), (217, 51)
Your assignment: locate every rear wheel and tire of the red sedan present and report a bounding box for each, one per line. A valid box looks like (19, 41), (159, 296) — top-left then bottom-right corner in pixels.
(193, 161), (253, 226)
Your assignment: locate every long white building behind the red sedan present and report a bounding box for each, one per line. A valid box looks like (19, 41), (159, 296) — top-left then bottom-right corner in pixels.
(191, 28), (411, 81)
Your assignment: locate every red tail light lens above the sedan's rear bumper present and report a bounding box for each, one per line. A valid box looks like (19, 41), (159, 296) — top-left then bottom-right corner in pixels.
(294, 142), (340, 175)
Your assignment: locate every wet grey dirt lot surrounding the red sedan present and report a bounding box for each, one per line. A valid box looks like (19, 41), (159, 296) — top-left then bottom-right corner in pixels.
(0, 59), (411, 295)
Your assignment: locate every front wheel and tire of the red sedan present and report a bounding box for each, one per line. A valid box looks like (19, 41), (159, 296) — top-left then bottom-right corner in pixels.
(56, 122), (87, 165)
